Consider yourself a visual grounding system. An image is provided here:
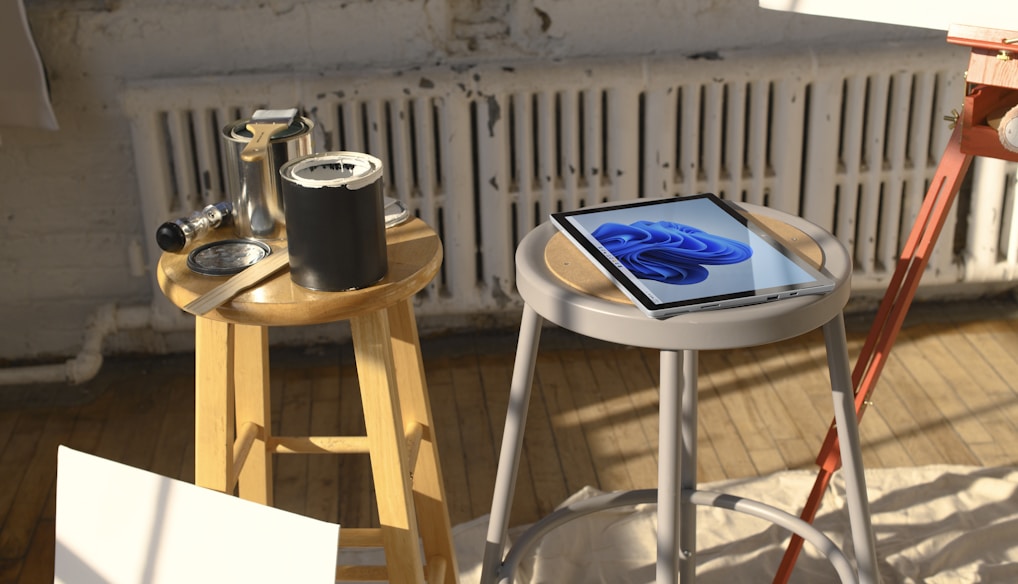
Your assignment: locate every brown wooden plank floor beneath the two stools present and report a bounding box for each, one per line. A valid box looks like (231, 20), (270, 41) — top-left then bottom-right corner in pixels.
(0, 302), (1018, 583)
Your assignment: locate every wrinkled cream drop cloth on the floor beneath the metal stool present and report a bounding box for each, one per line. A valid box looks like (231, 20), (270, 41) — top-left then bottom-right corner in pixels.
(454, 466), (1018, 584)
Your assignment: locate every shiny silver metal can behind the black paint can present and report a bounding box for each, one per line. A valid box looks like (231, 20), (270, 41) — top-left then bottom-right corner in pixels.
(222, 116), (315, 239)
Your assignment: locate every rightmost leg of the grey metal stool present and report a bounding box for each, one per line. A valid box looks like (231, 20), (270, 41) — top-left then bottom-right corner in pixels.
(824, 313), (880, 584)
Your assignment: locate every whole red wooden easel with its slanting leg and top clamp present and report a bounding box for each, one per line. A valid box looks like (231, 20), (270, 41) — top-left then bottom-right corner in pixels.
(774, 25), (1018, 584)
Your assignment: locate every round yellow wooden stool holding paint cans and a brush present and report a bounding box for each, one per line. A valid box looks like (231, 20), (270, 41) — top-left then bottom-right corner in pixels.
(158, 219), (457, 584)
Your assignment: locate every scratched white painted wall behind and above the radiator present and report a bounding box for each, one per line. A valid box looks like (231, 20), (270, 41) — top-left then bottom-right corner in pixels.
(0, 0), (943, 363)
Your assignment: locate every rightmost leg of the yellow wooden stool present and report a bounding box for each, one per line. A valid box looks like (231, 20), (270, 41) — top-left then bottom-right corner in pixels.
(389, 298), (458, 584)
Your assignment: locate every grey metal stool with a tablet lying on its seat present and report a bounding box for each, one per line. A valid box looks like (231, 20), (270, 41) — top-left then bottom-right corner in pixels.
(480, 205), (879, 584)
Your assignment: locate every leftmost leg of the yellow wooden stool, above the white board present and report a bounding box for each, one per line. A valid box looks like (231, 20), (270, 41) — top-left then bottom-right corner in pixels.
(194, 316), (236, 492)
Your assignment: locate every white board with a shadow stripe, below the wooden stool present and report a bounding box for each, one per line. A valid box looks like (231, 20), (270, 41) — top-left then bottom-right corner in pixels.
(54, 447), (339, 584)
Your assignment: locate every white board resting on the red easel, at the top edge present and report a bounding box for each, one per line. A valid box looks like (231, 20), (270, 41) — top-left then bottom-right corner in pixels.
(759, 0), (1018, 31)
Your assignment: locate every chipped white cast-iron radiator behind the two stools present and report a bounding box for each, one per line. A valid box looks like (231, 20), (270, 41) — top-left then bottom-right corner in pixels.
(126, 45), (1018, 329)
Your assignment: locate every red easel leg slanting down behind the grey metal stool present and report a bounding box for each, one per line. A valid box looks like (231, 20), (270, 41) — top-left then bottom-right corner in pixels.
(774, 124), (972, 584)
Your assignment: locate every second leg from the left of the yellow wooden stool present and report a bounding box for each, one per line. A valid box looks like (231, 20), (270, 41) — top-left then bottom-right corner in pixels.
(233, 325), (272, 505)
